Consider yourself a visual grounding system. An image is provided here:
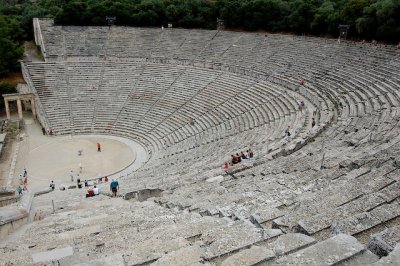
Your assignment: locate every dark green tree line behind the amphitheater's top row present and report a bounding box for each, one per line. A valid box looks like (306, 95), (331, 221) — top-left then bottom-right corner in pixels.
(0, 0), (400, 75)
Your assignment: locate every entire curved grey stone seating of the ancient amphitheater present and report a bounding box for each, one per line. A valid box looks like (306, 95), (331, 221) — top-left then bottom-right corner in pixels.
(0, 19), (400, 265)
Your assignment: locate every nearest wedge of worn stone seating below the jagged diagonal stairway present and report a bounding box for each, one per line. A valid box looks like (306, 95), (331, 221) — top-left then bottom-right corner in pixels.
(0, 186), (399, 265)
